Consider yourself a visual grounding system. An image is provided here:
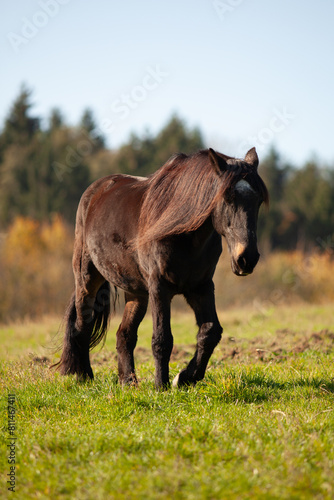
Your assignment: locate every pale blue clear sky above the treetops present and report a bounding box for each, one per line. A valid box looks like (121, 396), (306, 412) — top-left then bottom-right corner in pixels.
(0, 0), (334, 166)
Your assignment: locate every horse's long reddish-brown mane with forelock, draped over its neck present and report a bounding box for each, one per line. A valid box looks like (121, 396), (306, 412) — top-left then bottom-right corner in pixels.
(137, 149), (268, 245)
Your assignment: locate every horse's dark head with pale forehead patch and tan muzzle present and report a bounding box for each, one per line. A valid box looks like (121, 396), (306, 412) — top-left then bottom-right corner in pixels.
(209, 148), (268, 276)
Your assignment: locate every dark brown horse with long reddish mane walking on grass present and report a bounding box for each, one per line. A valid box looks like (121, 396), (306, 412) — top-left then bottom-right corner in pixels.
(53, 148), (268, 389)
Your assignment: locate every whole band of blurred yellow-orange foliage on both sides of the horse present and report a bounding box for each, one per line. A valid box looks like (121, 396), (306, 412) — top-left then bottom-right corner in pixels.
(0, 215), (334, 321)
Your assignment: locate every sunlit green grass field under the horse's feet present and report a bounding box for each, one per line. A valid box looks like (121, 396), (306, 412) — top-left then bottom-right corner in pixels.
(0, 303), (334, 500)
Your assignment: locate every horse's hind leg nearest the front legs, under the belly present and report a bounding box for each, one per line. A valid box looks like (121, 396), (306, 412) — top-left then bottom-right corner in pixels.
(117, 293), (148, 385)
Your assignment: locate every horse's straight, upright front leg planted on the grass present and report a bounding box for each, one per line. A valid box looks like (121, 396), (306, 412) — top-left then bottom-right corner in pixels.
(149, 278), (173, 389)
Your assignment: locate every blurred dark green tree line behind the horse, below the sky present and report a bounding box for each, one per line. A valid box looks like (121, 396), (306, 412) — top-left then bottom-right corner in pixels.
(0, 86), (334, 254)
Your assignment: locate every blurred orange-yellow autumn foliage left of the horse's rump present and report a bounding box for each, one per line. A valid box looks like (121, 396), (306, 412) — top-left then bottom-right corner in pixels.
(0, 216), (73, 321)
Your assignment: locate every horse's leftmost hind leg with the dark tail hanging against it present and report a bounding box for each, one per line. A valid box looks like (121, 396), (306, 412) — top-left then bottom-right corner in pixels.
(59, 254), (105, 380)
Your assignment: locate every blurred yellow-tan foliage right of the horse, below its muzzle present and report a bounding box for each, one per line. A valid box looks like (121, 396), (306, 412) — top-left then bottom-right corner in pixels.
(210, 251), (334, 310)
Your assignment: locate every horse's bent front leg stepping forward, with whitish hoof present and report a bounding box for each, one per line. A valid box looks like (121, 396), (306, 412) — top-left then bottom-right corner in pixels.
(173, 282), (223, 387)
